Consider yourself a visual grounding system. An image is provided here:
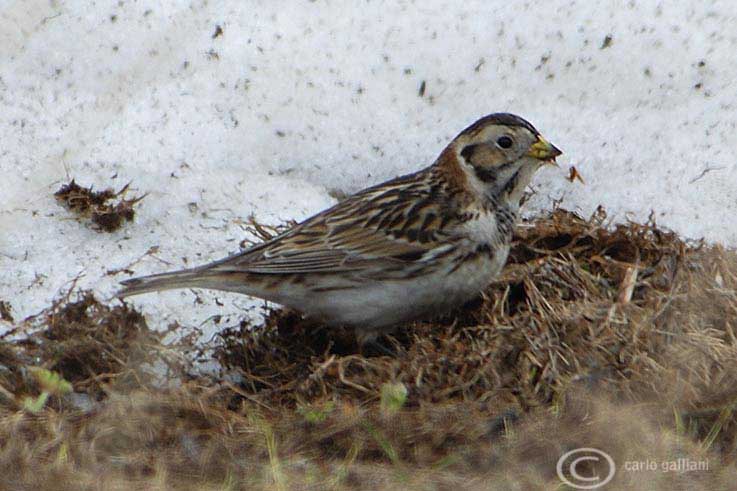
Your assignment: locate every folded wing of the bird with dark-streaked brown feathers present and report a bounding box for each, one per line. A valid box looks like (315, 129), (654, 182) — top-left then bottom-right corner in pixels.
(207, 170), (457, 274)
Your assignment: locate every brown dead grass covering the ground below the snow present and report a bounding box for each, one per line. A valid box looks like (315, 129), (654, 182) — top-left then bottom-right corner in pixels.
(0, 210), (737, 490)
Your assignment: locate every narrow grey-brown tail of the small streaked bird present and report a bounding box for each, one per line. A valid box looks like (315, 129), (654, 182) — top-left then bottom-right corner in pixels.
(116, 268), (229, 298)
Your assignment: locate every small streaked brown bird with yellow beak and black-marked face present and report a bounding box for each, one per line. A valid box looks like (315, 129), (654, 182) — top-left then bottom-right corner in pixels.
(118, 113), (561, 346)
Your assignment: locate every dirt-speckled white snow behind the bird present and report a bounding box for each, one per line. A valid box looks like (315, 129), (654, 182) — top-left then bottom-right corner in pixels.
(0, 0), (737, 335)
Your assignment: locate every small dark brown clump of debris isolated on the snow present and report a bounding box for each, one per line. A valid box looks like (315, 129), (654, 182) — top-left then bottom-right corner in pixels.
(54, 179), (146, 232)
